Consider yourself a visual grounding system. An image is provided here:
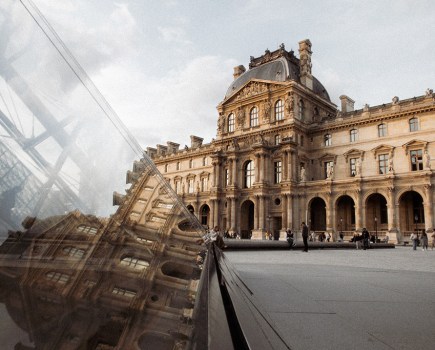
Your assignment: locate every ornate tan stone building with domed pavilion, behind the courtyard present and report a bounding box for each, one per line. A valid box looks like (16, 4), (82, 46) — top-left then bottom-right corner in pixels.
(147, 40), (435, 242)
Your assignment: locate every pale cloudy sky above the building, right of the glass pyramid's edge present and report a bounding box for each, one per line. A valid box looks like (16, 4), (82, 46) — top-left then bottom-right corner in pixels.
(33, 0), (435, 147)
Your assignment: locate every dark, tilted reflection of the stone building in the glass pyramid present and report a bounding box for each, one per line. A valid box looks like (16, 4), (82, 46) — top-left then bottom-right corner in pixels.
(0, 162), (204, 350)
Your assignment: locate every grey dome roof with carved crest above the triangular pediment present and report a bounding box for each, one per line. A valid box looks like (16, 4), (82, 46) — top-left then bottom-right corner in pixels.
(225, 47), (331, 102)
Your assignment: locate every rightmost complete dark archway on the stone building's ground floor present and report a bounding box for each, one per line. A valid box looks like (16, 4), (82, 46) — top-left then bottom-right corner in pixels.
(399, 191), (425, 235)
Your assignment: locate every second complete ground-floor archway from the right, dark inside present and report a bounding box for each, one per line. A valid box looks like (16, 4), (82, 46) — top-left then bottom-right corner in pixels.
(365, 193), (388, 232)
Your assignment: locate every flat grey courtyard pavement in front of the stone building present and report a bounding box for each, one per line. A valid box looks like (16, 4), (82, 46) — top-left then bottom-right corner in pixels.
(225, 247), (435, 350)
